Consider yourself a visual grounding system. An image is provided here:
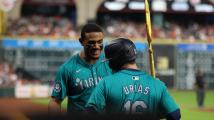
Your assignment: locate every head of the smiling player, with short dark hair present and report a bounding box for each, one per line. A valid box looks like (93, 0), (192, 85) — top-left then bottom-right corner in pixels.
(79, 23), (104, 60)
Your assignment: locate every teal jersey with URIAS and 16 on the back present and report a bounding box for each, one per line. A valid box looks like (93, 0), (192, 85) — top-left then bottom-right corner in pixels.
(86, 69), (179, 116)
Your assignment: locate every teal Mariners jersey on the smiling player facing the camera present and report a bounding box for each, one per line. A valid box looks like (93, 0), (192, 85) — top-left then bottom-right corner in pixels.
(52, 54), (111, 112)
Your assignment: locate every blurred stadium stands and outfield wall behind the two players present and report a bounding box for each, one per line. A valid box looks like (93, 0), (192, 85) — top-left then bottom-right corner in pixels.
(0, 0), (214, 98)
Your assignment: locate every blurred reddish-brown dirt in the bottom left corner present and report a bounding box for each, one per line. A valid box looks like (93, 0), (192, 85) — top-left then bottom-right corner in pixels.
(0, 98), (48, 120)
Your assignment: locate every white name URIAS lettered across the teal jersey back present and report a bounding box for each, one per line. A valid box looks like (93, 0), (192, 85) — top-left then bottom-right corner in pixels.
(123, 84), (150, 95)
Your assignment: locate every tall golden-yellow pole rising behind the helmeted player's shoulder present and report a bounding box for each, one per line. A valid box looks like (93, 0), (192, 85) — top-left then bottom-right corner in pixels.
(145, 0), (155, 78)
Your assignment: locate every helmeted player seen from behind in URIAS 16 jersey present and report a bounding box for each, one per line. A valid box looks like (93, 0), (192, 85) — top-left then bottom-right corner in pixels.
(86, 38), (180, 120)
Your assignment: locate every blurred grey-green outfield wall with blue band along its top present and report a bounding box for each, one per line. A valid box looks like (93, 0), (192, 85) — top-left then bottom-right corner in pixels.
(1, 38), (214, 89)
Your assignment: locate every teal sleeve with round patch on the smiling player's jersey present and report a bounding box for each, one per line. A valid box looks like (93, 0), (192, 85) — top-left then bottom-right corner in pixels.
(51, 66), (69, 101)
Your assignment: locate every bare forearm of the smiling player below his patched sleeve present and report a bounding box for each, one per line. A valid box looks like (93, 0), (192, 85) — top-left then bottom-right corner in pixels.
(48, 97), (62, 114)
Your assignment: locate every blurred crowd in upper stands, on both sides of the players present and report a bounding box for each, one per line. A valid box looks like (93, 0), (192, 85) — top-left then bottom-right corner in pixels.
(7, 16), (214, 42)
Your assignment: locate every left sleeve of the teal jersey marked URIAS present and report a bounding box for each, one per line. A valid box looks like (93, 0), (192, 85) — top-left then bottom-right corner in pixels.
(86, 79), (106, 113)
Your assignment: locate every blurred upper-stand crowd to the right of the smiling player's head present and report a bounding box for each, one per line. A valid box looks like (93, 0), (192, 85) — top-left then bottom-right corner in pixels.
(106, 20), (214, 42)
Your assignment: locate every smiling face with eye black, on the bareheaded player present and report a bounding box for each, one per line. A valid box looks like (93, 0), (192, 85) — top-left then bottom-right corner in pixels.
(83, 32), (104, 60)
